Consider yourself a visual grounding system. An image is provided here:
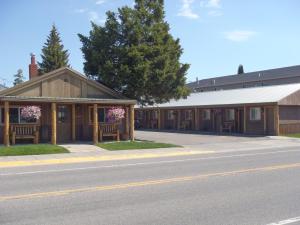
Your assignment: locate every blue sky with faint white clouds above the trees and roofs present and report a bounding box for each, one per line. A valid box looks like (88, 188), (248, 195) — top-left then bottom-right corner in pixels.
(0, 0), (300, 85)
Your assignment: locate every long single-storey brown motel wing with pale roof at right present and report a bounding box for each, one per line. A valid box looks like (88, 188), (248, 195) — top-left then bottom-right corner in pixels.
(135, 67), (300, 135)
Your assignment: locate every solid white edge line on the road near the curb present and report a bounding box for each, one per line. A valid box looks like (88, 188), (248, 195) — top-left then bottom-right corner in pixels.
(0, 149), (299, 176)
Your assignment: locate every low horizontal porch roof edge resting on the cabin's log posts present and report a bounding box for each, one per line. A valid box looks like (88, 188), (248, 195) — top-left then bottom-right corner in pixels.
(0, 96), (136, 105)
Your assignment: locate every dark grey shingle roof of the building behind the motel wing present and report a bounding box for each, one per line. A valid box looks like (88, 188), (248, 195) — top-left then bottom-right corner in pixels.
(187, 65), (300, 88)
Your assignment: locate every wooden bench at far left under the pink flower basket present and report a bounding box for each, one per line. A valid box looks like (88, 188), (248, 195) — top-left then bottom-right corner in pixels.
(10, 124), (39, 145)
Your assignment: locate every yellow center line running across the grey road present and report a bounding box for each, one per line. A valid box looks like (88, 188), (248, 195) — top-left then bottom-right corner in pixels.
(0, 163), (300, 202)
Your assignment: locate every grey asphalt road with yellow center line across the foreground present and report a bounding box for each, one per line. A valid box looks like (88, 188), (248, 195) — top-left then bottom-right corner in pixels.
(0, 147), (300, 225)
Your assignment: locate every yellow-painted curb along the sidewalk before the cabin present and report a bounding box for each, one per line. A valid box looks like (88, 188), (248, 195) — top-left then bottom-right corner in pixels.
(0, 151), (214, 168)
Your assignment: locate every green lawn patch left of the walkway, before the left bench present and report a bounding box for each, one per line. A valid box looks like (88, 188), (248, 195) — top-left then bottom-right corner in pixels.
(0, 144), (69, 156)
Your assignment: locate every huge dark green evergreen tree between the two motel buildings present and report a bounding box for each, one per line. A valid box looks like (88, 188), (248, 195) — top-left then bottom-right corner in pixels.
(79, 0), (189, 105)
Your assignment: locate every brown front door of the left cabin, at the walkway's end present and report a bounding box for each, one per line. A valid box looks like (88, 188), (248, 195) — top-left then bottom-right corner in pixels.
(56, 105), (72, 143)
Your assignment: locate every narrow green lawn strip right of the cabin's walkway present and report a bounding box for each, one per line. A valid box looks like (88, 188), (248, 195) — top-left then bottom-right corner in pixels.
(98, 141), (181, 151)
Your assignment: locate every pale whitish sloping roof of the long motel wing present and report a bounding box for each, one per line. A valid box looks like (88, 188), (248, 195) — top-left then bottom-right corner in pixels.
(140, 84), (300, 108)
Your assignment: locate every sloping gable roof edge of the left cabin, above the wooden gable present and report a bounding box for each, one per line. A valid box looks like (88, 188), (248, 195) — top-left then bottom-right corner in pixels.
(0, 67), (127, 99)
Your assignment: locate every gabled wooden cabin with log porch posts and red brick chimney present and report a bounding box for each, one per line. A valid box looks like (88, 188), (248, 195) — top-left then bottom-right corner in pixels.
(0, 55), (136, 145)
